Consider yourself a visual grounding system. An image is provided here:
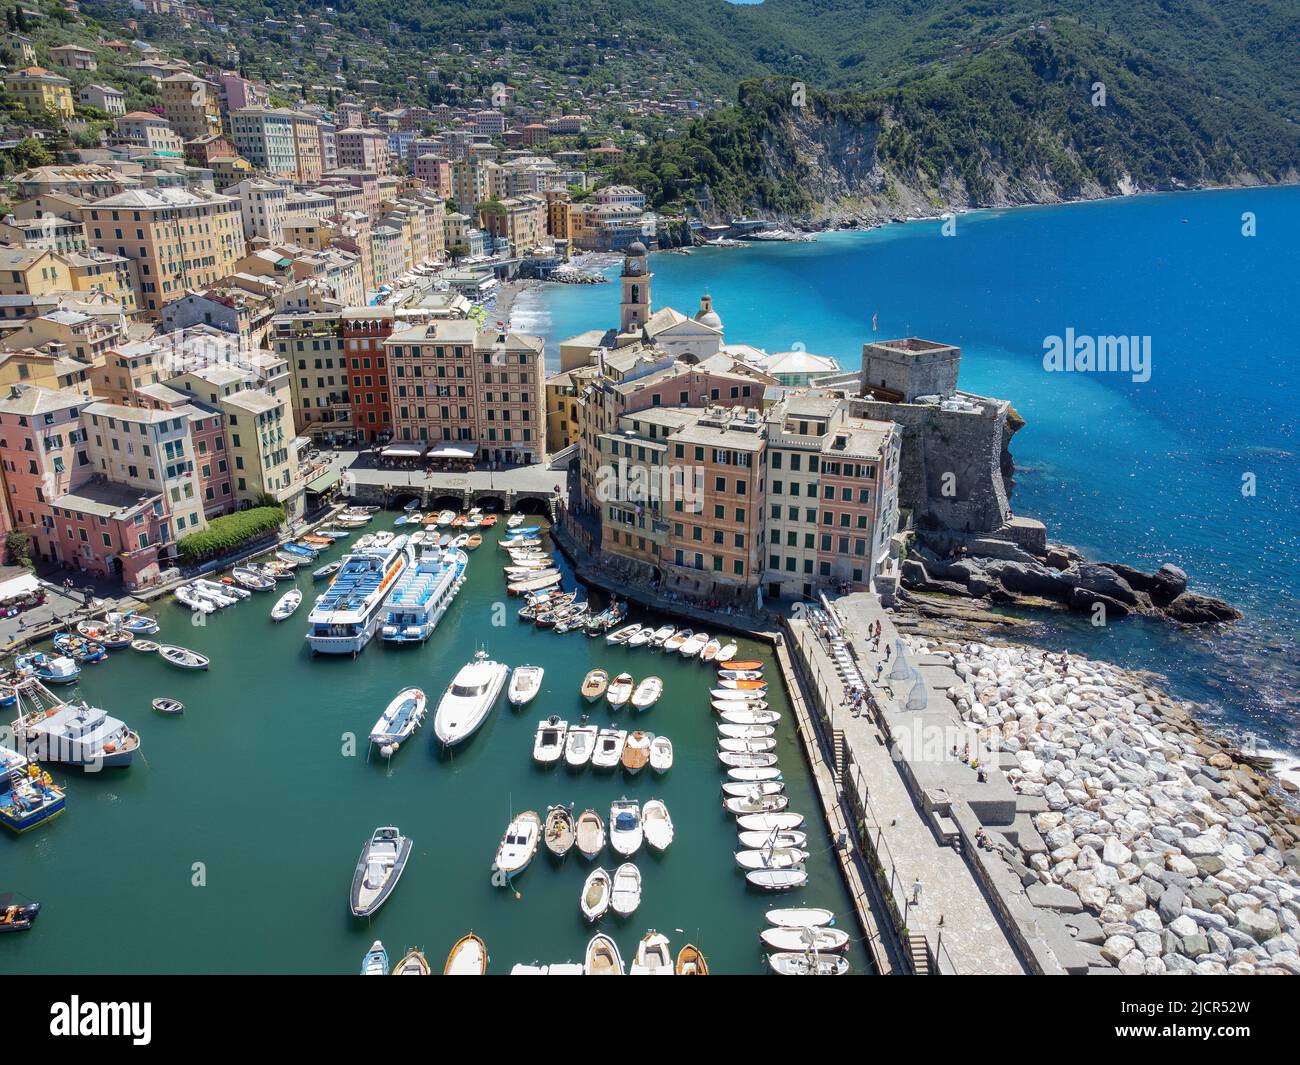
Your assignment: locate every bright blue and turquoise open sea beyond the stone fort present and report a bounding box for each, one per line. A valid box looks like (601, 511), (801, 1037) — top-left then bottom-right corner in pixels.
(512, 187), (1300, 752)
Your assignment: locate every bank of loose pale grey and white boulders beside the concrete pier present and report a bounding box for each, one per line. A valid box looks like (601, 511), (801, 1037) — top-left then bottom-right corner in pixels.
(909, 637), (1300, 974)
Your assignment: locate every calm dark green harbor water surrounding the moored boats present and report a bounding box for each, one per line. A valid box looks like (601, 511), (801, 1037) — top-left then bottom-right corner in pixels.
(0, 514), (870, 974)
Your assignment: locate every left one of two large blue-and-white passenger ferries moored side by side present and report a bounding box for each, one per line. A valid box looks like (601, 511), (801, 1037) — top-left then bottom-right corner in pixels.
(307, 536), (415, 654)
